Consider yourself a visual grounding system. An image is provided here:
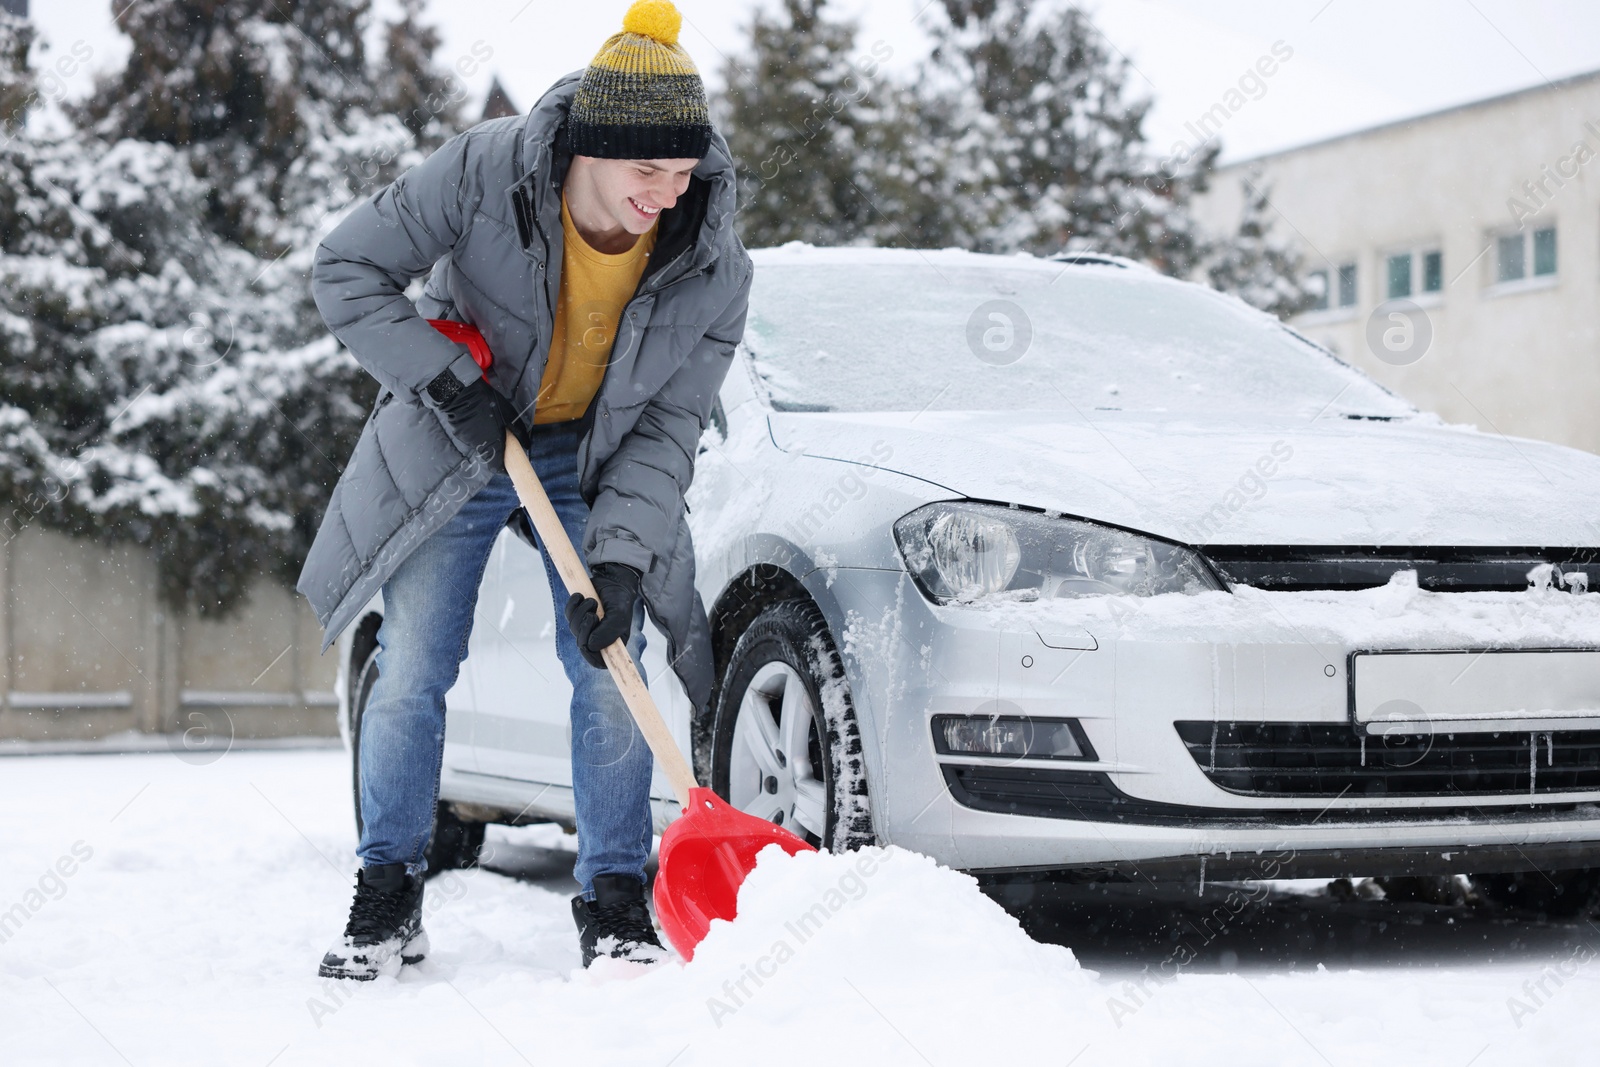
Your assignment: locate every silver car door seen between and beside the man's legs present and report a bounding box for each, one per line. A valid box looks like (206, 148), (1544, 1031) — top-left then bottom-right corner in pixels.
(467, 530), (690, 797)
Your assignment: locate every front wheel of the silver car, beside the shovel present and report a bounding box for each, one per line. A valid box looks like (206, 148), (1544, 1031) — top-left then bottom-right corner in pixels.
(712, 600), (874, 853)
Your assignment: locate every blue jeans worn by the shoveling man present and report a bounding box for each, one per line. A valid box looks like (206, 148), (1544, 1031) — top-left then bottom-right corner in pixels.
(358, 422), (651, 897)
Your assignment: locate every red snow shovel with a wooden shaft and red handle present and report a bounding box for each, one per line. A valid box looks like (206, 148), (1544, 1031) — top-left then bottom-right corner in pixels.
(429, 320), (816, 960)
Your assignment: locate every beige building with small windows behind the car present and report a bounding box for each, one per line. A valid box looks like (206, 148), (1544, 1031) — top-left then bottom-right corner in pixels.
(1197, 72), (1600, 451)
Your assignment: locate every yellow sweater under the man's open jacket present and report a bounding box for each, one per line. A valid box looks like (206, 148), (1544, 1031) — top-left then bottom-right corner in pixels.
(533, 197), (659, 426)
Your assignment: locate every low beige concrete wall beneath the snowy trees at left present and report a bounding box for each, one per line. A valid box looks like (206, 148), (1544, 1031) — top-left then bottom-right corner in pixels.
(0, 528), (338, 744)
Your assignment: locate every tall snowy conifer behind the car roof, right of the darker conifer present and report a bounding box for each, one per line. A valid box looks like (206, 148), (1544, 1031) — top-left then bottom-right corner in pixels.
(933, 0), (1216, 275)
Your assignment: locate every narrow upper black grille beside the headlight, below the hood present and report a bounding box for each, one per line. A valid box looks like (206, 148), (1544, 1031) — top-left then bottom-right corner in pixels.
(1200, 544), (1600, 592)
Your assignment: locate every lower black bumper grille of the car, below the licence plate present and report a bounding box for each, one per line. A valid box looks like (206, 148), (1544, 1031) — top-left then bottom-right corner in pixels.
(1174, 721), (1600, 798)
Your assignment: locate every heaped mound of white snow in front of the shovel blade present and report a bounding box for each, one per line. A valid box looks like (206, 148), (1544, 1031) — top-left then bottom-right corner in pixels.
(556, 846), (1106, 1064)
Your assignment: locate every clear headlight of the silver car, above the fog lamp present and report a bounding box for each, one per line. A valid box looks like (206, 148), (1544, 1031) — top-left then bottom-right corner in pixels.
(894, 502), (1222, 603)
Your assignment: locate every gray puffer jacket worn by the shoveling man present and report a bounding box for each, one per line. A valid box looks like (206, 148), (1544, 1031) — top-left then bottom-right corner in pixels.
(299, 74), (752, 709)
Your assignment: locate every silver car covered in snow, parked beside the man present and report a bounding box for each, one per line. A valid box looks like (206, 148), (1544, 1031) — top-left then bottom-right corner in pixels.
(341, 245), (1600, 907)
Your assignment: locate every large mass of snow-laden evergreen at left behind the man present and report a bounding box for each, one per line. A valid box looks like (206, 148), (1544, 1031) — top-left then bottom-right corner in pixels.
(0, 0), (453, 613)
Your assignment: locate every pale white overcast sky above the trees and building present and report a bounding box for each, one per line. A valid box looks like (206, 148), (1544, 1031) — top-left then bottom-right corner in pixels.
(32, 0), (1600, 160)
